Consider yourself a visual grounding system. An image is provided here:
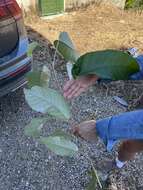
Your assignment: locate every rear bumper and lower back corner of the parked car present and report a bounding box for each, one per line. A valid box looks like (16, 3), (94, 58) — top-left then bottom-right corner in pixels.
(0, 38), (32, 97)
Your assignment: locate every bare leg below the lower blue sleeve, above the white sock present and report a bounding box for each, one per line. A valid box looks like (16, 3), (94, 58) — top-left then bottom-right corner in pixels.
(118, 140), (143, 162)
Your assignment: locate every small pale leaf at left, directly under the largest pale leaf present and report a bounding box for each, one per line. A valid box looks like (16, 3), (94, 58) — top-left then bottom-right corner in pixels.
(24, 118), (46, 137)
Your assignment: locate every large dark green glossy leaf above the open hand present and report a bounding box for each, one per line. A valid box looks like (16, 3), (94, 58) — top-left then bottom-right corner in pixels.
(72, 50), (139, 80)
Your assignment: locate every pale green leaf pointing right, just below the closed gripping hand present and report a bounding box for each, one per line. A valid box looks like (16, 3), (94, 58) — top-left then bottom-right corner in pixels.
(40, 136), (78, 157)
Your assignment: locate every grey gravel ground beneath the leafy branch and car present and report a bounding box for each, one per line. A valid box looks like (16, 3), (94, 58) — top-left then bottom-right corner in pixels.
(0, 32), (143, 190)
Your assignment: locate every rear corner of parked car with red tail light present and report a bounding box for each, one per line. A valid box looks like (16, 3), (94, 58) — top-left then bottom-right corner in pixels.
(0, 0), (32, 97)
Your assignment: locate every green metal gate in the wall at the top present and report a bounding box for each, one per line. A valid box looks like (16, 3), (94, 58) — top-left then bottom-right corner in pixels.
(39, 0), (64, 16)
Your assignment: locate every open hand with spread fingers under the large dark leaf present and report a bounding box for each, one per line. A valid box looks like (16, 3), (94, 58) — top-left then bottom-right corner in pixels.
(64, 75), (98, 99)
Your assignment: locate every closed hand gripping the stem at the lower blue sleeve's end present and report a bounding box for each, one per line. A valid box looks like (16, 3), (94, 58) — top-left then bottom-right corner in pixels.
(72, 120), (97, 141)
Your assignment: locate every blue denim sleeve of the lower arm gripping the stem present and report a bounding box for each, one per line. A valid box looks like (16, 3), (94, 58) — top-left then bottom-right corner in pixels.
(96, 110), (143, 151)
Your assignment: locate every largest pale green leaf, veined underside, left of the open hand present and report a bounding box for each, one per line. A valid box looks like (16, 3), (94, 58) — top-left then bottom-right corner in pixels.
(24, 86), (70, 120)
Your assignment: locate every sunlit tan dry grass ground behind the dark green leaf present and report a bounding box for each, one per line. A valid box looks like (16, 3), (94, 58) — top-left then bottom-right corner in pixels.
(25, 5), (143, 53)
